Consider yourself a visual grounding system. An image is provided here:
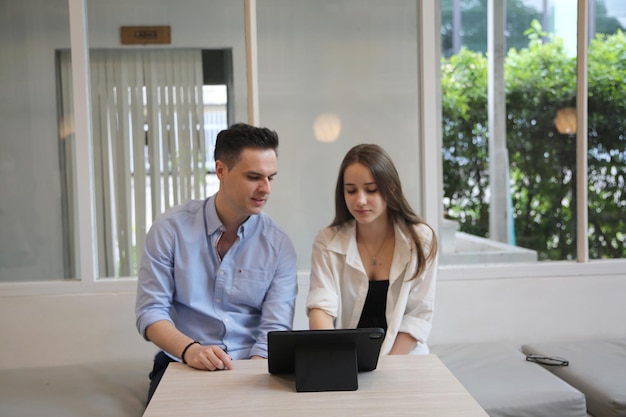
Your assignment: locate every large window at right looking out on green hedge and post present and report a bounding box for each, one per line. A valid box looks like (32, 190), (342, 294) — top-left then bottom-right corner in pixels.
(442, 0), (626, 263)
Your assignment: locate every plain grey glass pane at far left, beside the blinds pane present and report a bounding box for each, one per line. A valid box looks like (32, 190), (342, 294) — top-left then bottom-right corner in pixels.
(0, 0), (77, 282)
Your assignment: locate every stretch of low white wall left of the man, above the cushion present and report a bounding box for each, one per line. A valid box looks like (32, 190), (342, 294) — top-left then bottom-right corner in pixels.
(0, 291), (156, 369)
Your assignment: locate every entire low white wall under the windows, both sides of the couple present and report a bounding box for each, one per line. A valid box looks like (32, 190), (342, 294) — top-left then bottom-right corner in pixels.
(0, 264), (626, 369)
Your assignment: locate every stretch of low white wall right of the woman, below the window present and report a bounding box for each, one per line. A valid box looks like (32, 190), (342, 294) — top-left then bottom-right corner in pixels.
(430, 263), (626, 344)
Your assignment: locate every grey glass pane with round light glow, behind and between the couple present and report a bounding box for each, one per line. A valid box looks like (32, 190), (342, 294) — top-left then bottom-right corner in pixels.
(257, 0), (422, 270)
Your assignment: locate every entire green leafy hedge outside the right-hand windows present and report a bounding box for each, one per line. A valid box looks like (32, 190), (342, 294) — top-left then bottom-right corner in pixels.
(442, 22), (626, 260)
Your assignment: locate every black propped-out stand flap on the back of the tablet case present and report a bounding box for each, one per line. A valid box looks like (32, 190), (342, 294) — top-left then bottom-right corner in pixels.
(295, 344), (359, 392)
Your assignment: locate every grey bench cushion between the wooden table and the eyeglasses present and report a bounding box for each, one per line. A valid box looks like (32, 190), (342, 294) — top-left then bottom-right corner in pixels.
(430, 343), (587, 417)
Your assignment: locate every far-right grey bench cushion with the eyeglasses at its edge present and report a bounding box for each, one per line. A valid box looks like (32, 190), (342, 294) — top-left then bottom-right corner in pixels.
(522, 339), (626, 417)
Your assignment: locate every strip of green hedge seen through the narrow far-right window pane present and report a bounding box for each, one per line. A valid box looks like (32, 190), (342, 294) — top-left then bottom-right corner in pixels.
(588, 31), (626, 258)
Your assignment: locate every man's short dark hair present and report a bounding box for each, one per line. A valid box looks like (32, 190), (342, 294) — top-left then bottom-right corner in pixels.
(213, 123), (278, 169)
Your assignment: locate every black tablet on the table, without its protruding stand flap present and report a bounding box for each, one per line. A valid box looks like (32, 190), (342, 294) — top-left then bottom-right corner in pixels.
(267, 328), (385, 374)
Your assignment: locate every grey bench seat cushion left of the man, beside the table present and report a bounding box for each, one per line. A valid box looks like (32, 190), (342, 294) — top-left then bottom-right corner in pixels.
(0, 358), (152, 417)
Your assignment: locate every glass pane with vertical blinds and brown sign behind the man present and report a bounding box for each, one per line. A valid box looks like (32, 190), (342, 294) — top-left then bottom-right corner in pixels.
(80, 0), (239, 278)
